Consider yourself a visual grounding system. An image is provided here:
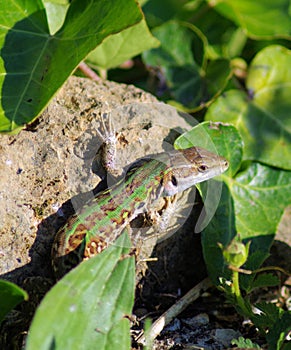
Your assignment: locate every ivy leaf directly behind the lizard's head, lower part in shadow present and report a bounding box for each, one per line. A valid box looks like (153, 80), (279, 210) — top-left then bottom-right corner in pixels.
(175, 122), (243, 284)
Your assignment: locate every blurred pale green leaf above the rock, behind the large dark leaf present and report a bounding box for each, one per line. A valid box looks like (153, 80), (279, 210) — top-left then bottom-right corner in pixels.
(87, 20), (159, 69)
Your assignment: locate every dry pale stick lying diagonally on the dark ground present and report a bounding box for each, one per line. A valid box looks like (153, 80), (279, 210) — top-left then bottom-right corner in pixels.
(136, 278), (212, 345)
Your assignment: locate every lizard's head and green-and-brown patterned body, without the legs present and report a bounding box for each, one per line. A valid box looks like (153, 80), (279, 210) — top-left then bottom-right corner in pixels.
(52, 147), (228, 278)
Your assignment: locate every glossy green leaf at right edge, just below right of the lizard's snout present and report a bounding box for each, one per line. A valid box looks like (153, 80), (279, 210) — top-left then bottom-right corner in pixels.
(225, 163), (291, 239)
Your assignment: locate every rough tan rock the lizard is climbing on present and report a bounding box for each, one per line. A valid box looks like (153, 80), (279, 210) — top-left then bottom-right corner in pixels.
(0, 77), (208, 285)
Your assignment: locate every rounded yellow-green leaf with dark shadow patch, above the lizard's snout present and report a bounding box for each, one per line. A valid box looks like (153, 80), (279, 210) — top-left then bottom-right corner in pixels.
(205, 46), (291, 170)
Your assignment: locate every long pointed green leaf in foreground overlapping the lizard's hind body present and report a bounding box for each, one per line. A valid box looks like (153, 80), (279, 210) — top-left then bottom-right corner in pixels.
(26, 234), (135, 350)
